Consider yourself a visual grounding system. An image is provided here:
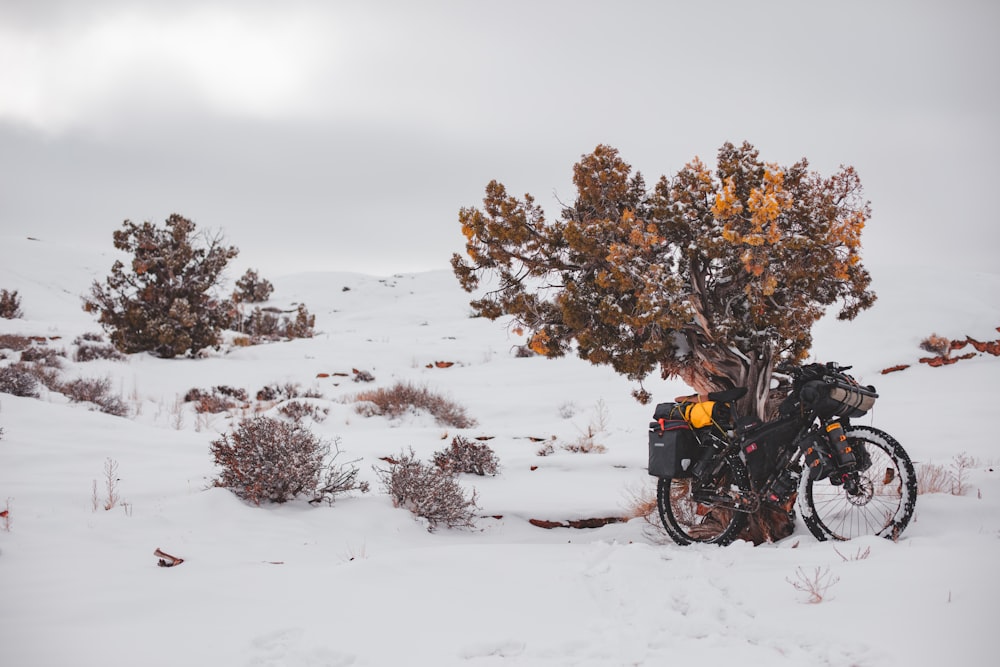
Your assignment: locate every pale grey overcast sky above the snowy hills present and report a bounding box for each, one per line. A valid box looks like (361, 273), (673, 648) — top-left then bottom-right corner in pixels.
(0, 0), (1000, 275)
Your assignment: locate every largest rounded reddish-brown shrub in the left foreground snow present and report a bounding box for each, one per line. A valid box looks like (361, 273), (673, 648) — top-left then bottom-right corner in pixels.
(211, 417), (364, 505)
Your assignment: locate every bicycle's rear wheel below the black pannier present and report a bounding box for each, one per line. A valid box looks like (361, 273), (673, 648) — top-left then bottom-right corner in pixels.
(656, 456), (750, 546)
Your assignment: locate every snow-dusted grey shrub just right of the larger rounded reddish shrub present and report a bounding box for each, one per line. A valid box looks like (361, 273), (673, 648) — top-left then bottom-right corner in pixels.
(375, 449), (479, 532)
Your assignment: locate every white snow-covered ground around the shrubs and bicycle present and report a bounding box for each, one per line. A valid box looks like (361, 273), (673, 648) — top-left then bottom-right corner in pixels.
(0, 237), (1000, 667)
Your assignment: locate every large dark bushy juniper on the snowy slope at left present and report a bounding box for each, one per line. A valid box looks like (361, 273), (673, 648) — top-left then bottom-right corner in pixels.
(84, 214), (239, 358)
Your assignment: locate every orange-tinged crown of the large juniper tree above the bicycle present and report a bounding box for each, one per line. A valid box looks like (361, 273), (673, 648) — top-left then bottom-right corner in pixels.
(452, 143), (875, 417)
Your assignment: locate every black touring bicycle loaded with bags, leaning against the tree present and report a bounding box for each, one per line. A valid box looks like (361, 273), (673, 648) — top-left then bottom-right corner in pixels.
(649, 363), (917, 545)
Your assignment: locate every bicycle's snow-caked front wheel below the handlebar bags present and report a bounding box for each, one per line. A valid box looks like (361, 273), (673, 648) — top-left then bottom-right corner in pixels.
(799, 426), (917, 541)
